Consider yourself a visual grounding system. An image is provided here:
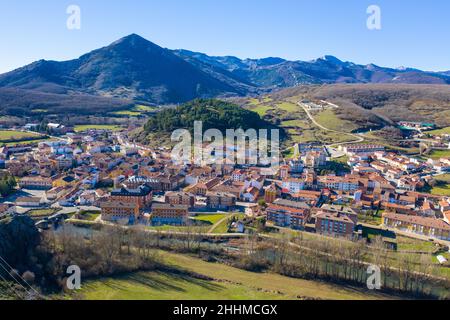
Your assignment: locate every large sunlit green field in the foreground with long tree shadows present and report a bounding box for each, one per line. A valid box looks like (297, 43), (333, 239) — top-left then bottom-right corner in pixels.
(71, 252), (390, 300)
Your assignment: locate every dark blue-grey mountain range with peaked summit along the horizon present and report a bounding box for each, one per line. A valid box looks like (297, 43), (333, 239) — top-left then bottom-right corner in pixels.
(0, 34), (450, 105)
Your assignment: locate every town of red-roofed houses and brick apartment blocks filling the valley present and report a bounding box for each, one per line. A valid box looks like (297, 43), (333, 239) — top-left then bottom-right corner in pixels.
(0, 116), (450, 261)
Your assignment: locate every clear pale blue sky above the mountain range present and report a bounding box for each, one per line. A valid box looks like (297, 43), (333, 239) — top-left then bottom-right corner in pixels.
(0, 0), (450, 72)
